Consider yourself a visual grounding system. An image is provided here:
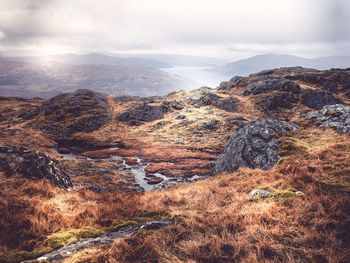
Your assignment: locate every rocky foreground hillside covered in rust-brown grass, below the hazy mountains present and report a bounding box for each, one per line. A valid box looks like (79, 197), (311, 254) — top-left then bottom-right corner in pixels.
(0, 67), (350, 262)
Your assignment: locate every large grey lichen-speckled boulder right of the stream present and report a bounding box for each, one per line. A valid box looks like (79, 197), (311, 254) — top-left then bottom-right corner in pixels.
(215, 118), (298, 173)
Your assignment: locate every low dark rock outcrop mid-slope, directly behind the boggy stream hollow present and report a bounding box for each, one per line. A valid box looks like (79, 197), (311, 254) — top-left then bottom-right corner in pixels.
(117, 103), (171, 122)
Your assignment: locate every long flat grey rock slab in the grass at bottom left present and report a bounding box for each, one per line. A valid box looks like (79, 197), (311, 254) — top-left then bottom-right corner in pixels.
(22, 221), (172, 263)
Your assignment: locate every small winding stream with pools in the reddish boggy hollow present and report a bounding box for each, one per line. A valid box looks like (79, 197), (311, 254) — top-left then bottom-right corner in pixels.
(50, 148), (208, 192)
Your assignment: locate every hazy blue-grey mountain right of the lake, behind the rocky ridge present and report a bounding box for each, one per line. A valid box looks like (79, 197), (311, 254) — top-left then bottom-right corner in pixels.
(208, 54), (350, 77)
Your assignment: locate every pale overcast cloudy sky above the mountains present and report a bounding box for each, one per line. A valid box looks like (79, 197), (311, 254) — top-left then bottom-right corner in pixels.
(0, 0), (350, 59)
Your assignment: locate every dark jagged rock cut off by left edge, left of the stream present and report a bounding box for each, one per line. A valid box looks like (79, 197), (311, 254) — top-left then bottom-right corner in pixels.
(0, 146), (73, 188)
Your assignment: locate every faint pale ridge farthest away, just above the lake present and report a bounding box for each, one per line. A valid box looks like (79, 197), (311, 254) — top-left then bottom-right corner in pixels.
(108, 53), (228, 67)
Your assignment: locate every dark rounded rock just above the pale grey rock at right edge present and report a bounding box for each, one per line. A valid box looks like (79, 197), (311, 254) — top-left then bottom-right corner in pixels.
(302, 90), (342, 110)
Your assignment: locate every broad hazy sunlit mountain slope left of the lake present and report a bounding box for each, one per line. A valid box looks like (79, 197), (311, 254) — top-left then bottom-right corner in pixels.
(0, 55), (200, 98)
